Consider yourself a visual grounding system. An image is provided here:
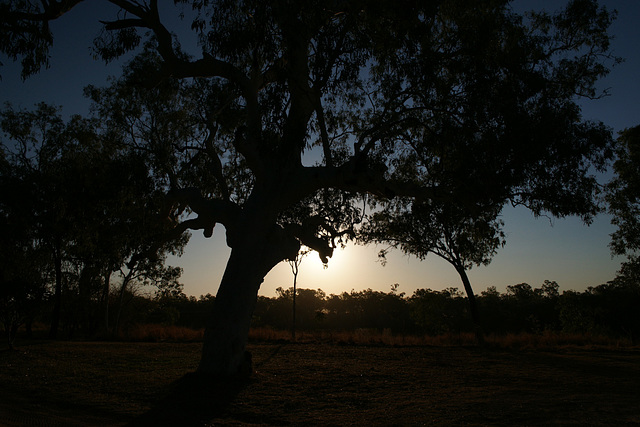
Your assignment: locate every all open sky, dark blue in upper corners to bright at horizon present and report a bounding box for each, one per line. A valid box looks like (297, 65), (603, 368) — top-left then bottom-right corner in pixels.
(0, 0), (640, 296)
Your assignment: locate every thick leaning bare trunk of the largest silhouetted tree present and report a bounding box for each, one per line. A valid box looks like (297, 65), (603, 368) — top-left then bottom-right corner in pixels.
(198, 227), (300, 377)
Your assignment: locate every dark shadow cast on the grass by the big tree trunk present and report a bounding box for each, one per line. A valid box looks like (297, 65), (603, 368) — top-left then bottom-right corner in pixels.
(128, 373), (251, 427)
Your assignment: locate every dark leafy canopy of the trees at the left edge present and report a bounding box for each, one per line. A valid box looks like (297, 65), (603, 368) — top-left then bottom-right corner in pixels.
(0, 100), (189, 342)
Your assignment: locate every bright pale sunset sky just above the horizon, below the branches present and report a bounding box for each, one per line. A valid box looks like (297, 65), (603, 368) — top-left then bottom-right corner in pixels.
(170, 208), (621, 296)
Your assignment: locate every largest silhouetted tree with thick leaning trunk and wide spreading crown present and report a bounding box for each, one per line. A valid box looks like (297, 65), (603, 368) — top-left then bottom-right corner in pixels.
(0, 0), (614, 376)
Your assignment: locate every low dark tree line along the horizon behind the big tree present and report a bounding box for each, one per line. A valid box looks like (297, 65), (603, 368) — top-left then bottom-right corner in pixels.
(6, 278), (640, 345)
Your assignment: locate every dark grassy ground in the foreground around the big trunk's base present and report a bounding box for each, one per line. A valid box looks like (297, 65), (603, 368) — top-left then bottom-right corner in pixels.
(0, 340), (640, 426)
